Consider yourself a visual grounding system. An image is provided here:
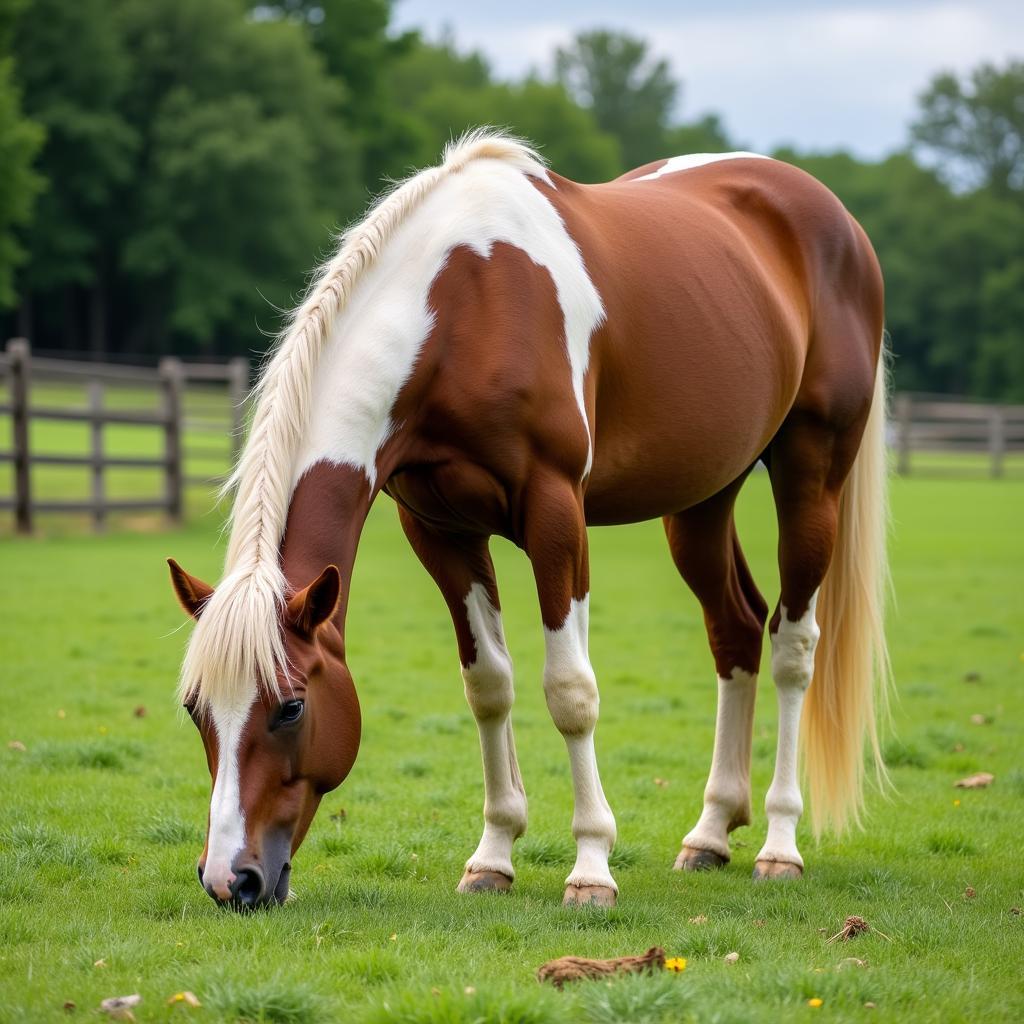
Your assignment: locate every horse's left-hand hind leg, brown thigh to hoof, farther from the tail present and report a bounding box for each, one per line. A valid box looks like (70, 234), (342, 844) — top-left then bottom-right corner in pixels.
(665, 479), (768, 871)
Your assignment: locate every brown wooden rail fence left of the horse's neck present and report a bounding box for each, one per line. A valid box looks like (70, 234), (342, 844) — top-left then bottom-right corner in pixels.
(0, 338), (249, 534)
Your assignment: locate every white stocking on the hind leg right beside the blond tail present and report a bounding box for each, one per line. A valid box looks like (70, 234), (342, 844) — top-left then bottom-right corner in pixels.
(757, 591), (820, 867)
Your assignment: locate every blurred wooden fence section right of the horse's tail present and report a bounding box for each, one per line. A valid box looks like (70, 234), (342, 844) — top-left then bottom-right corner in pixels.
(890, 392), (1024, 477)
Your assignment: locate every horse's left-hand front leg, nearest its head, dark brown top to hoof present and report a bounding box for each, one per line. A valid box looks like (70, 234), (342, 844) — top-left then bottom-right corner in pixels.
(399, 508), (526, 892)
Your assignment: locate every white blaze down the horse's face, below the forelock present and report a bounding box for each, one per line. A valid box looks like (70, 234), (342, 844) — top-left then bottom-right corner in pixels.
(203, 693), (255, 899)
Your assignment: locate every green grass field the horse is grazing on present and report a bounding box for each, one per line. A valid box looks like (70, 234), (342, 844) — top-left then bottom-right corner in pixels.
(0, 468), (1024, 1024)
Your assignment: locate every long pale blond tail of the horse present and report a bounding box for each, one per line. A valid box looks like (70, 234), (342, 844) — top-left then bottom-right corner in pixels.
(800, 344), (892, 836)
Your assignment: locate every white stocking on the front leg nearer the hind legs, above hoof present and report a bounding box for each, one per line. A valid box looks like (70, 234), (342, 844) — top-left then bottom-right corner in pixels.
(544, 595), (618, 893)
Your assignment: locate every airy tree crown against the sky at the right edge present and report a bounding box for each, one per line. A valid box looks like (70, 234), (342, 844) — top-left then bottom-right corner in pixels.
(911, 60), (1024, 197)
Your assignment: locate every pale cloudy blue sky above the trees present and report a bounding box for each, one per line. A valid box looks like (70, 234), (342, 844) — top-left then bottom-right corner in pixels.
(394, 0), (1024, 159)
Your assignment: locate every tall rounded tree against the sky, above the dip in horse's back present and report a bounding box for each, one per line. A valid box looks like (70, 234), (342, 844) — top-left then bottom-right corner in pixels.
(555, 30), (679, 167)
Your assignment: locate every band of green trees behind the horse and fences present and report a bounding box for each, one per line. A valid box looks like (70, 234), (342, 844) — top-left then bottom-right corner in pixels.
(0, 0), (1024, 400)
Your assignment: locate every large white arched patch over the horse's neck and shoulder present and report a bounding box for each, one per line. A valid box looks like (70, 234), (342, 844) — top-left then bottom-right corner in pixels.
(293, 160), (604, 485)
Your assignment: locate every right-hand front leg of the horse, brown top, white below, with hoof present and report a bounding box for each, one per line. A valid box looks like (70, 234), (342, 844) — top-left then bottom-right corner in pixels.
(524, 473), (618, 906)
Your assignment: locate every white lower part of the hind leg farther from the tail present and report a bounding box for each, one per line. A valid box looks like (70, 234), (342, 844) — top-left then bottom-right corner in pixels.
(683, 669), (758, 860)
